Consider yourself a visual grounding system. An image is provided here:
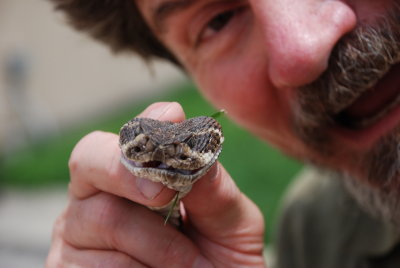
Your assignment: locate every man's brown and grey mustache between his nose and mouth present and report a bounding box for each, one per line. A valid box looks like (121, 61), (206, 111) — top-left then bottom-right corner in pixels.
(293, 4), (400, 148)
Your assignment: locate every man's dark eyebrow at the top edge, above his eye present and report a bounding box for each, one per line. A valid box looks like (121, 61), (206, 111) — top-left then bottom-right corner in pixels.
(152, 0), (199, 32)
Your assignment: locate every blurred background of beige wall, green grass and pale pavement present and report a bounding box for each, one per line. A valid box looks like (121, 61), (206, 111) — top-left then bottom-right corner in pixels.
(0, 0), (301, 268)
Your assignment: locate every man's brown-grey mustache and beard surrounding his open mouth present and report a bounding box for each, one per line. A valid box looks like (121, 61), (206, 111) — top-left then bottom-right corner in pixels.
(292, 4), (400, 224)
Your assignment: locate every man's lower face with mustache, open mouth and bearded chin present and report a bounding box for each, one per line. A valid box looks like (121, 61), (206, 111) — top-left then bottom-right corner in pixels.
(292, 2), (400, 224)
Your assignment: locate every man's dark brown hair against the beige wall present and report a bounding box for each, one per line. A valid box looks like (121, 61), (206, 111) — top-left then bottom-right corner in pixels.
(50, 0), (179, 65)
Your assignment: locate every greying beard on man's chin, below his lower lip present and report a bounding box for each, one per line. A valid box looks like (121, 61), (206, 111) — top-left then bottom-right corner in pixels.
(341, 124), (400, 226)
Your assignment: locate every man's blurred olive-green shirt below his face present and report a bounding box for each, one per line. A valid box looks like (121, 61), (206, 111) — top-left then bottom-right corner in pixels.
(274, 169), (400, 268)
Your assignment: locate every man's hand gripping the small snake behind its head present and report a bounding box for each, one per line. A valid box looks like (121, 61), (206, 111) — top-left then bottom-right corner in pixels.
(46, 103), (264, 268)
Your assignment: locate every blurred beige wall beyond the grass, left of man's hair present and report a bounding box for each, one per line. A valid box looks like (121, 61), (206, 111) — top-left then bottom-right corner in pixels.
(0, 0), (185, 150)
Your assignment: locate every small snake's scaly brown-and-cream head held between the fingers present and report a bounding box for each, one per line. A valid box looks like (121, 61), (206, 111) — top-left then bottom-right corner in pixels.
(120, 116), (224, 227)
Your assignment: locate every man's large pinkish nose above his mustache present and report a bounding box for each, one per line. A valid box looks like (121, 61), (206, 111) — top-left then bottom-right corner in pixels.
(250, 0), (356, 87)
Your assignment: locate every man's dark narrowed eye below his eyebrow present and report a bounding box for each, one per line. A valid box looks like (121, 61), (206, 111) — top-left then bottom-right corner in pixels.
(196, 7), (243, 46)
